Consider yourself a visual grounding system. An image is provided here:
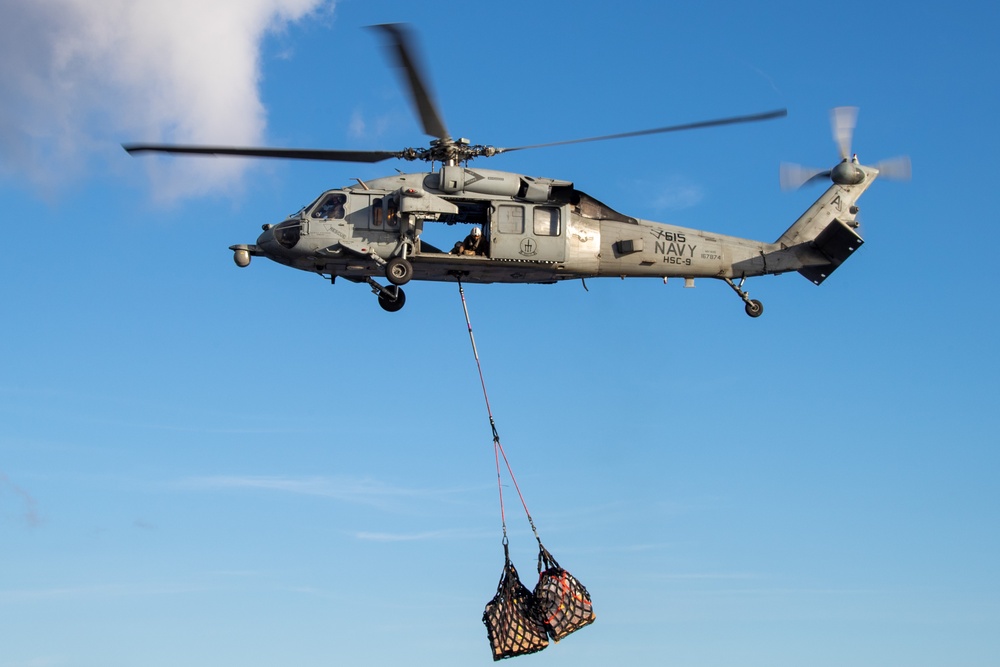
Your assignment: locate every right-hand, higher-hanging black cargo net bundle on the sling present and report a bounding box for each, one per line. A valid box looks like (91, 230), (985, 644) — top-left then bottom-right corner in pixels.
(534, 542), (595, 641)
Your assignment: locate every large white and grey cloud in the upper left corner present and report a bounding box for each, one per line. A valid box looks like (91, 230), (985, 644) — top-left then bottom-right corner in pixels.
(0, 0), (333, 197)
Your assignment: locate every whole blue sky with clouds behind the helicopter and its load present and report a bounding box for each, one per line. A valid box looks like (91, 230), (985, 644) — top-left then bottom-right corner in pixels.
(0, 0), (1000, 667)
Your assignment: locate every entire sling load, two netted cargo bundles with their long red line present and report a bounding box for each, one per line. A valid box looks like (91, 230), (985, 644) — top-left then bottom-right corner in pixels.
(458, 278), (595, 660)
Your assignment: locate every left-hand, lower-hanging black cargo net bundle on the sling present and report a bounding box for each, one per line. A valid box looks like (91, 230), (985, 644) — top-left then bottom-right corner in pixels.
(483, 544), (549, 660)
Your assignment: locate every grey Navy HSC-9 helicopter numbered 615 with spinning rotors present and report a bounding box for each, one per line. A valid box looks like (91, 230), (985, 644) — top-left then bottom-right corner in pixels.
(123, 24), (908, 317)
